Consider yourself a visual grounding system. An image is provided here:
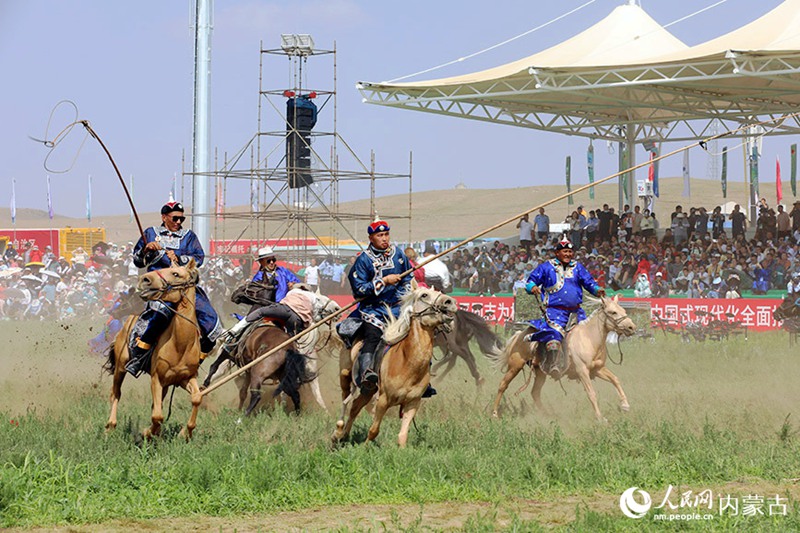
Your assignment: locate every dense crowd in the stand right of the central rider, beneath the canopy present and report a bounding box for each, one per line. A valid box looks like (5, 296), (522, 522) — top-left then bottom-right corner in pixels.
(445, 200), (800, 298)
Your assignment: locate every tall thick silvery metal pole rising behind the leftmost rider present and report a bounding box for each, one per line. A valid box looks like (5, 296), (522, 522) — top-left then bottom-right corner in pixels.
(192, 0), (209, 250)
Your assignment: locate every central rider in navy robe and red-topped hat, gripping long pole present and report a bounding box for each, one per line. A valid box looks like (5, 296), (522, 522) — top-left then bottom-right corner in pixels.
(337, 220), (422, 395)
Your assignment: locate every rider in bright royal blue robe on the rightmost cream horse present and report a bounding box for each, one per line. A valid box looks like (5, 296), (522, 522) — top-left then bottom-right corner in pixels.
(525, 238), (606, 379)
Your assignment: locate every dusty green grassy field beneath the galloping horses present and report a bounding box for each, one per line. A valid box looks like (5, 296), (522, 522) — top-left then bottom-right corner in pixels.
(0, 322), (800, 531)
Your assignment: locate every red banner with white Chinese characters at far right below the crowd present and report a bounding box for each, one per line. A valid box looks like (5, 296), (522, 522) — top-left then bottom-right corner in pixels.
(644, 298), (783, 331)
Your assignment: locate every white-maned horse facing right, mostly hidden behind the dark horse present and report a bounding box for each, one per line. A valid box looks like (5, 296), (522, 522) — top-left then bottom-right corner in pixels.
(202, 293), (344, 412)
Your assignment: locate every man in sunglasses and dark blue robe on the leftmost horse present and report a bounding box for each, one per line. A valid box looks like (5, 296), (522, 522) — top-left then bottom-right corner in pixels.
(125, 201), (223, 377)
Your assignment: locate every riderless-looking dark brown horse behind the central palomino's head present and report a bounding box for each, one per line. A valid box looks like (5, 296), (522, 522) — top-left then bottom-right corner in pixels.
(431, 309), (503, 387)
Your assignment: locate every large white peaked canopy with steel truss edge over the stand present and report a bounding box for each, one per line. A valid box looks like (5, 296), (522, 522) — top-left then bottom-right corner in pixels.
(357, 0), (800, 206)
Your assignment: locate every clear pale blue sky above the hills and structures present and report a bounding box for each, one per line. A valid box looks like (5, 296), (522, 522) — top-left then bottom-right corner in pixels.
(0, 0), (795, 217)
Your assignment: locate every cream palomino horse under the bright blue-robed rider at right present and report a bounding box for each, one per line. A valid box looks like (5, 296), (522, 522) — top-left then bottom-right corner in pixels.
(492, 295), (636, 420)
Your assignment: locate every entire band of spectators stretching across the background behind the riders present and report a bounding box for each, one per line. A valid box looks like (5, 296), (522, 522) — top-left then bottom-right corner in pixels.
(0, 200), (800, 319)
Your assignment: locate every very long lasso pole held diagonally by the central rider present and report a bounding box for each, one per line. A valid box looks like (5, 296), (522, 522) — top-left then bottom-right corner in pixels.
(200, 112), (800, 396)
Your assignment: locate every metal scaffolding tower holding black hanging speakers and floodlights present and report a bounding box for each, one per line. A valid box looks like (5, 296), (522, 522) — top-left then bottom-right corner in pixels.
(184, 35), (412, 264)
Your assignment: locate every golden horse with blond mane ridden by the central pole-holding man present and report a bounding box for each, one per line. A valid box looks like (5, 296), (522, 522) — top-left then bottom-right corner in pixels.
(332, 288), (458, 448)
